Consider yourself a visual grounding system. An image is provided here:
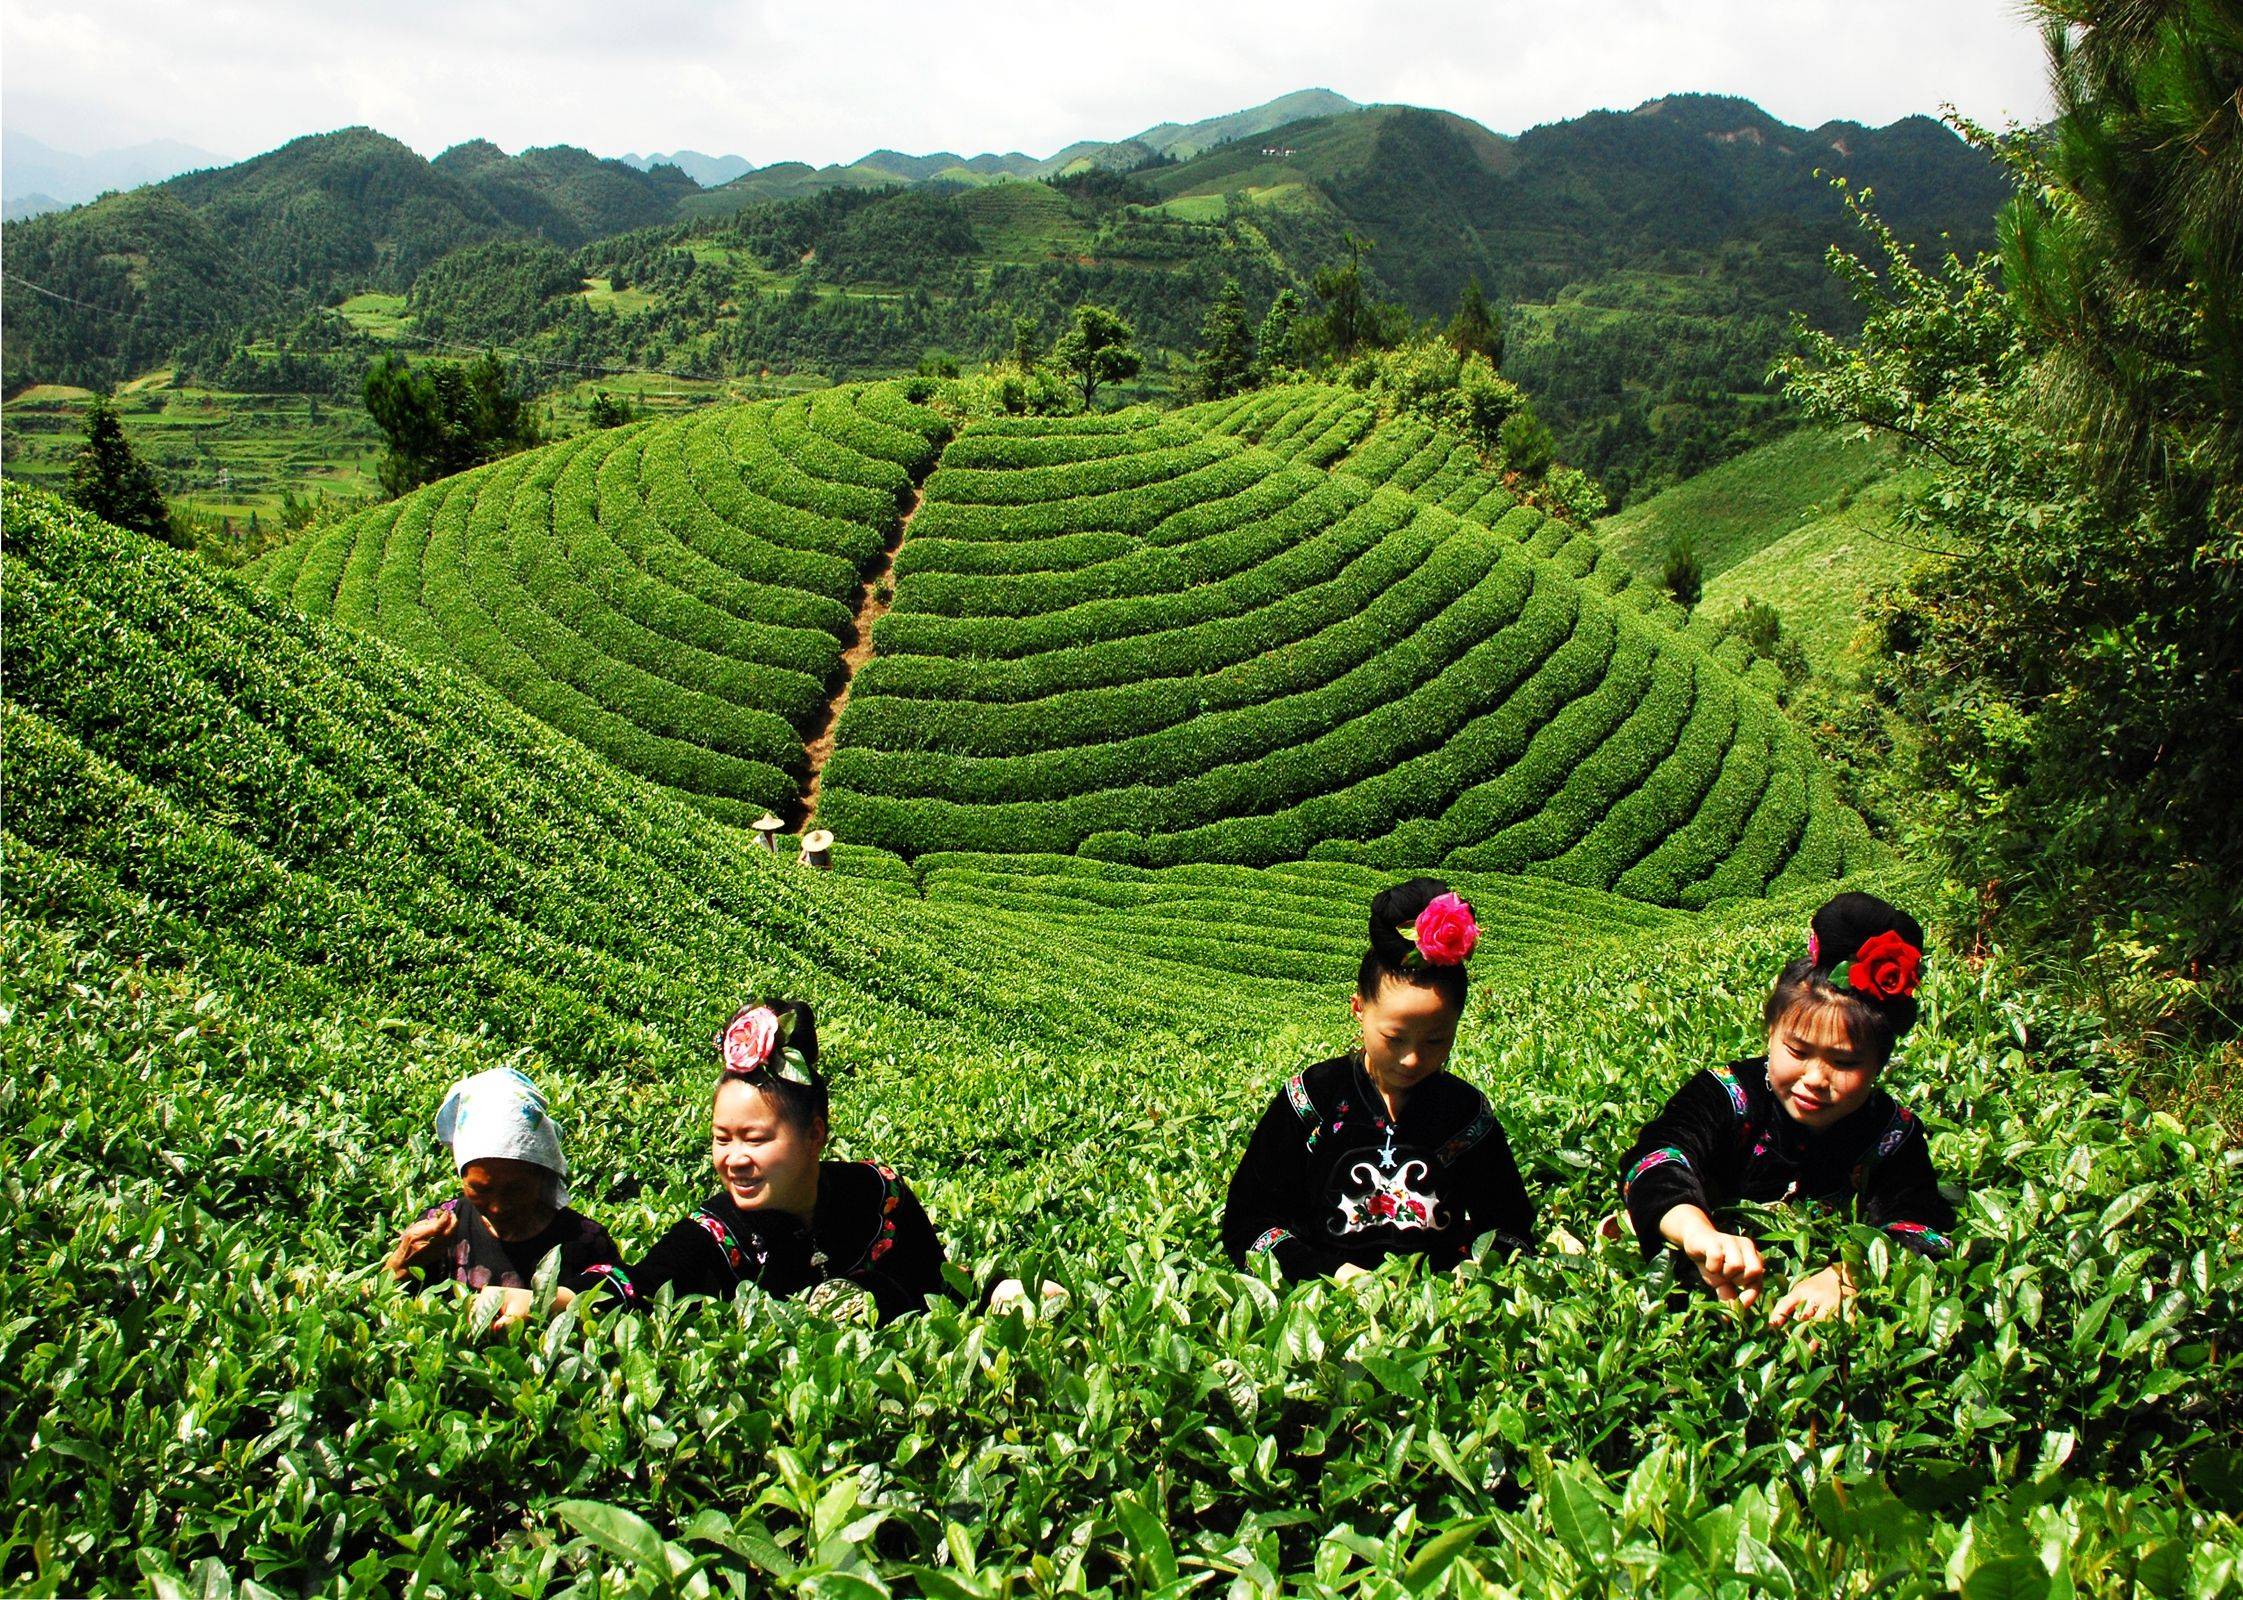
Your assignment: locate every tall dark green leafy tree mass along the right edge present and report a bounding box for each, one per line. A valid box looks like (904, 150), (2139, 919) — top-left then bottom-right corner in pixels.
(1785, 0), (2243, 1030)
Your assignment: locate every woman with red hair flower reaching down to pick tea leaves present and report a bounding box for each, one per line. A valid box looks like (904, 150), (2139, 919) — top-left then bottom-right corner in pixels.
(1622, 893), (1956, 1326)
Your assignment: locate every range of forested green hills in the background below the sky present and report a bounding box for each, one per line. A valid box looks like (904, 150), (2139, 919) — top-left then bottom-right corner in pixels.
(4, 90), (2003, 498)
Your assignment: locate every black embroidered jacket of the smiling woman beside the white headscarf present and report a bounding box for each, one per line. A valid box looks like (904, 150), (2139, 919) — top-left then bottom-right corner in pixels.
(563, 1160), (947, 1322)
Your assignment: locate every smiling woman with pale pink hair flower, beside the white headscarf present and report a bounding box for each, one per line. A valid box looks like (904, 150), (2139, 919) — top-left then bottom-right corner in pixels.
(509, 1001), (944, 1322)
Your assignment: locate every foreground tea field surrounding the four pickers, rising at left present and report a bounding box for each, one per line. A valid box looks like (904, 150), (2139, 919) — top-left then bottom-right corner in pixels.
(0, 485), (2243, 1600)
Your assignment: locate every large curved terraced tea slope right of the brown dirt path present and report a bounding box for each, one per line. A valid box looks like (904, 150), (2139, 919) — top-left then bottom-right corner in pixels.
(821, 406), (1868, 907)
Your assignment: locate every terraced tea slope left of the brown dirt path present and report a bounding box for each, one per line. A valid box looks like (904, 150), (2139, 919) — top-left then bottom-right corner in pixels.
(253, 384), (949, 821)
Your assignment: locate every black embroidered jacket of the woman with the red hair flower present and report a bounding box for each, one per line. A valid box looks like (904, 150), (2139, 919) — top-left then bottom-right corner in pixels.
(1622, 1055), (1956, 1257)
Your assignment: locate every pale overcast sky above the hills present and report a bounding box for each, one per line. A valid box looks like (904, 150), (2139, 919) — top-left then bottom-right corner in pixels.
(0, 0), (2048, 166)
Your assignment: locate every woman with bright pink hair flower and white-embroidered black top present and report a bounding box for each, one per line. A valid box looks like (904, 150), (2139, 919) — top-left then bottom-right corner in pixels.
(1222, 877), (1534, 1279)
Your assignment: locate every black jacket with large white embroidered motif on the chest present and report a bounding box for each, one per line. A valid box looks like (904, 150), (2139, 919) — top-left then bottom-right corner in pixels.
(1222, 1055), (1534, 1279)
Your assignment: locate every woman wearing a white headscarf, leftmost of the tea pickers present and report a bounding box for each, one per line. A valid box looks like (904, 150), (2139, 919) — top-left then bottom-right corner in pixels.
(386, 1066), (621, 1288)
